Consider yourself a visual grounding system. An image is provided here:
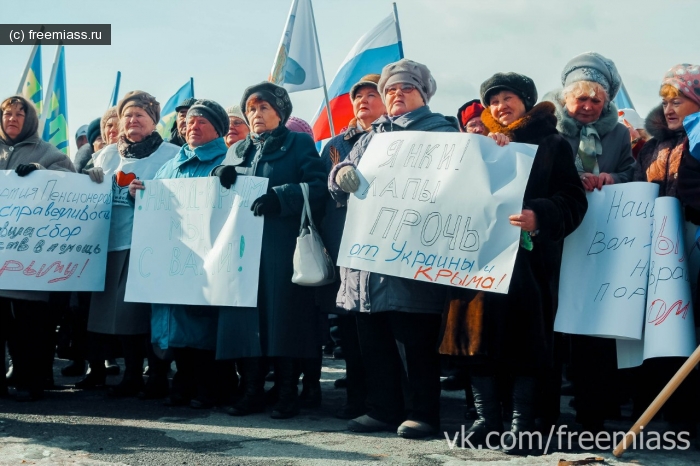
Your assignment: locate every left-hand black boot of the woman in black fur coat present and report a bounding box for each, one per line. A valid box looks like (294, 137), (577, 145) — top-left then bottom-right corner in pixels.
(466, 377), (503, 448)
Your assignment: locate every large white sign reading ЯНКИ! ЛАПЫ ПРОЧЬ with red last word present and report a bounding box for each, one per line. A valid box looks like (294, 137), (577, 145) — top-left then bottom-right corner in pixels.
(338, 131), (537, 293)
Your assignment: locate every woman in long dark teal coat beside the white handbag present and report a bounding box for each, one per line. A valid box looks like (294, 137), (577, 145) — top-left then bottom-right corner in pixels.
(213, 82), (328, 419)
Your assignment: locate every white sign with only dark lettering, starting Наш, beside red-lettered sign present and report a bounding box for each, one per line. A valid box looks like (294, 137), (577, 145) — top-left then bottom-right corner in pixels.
(554, 183), (659, 339)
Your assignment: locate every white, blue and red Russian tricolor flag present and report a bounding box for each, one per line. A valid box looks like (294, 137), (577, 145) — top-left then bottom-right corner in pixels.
(313, 14), (403, 142)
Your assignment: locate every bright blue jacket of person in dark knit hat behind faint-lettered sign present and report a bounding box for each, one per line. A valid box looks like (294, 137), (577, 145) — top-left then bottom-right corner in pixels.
(146, 138), (227, 350)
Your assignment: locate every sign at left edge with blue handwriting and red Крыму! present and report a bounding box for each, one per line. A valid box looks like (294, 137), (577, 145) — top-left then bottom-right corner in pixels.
(0, 170), (112, 291)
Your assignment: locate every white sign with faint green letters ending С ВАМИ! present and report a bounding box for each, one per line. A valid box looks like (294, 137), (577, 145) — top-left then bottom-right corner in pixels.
(125, 176), (267, 306)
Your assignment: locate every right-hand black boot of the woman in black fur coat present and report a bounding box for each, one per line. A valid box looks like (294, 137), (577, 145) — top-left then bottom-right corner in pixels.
(506, 377), (539, 456)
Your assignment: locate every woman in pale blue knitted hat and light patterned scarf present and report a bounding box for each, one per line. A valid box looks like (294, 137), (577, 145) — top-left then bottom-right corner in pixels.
(544, 52), (634, 432)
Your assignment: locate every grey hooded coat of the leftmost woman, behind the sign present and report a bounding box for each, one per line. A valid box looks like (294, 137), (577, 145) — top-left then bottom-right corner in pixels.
(0, 130), (75, 302)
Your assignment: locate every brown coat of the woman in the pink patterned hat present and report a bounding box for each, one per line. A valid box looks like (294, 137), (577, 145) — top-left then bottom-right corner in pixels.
(634, 105), (690, 197)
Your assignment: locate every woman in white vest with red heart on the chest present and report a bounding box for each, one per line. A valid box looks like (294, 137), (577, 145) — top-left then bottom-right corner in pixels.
(78, 91), (179, 398)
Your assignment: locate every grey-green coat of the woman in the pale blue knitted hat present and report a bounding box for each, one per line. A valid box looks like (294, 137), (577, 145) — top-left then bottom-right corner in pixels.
(543, 91), (634, 183)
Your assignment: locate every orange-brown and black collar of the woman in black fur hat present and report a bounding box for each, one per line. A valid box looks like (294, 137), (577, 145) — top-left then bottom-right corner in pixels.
(481, 102), (557, 144)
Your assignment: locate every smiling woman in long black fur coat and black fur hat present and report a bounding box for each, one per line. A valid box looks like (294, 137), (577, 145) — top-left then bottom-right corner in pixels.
(440, 73), (588, 452)
